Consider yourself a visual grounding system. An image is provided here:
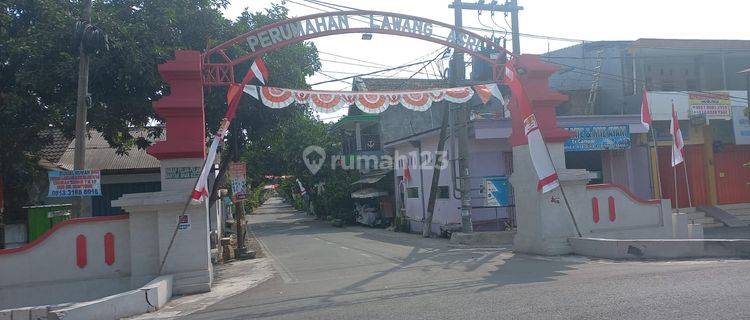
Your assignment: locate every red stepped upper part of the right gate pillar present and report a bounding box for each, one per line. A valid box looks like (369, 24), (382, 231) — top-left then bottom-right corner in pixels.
(509, 54), (570, 146)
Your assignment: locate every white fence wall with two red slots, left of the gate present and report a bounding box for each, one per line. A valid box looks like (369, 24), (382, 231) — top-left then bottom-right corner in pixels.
(0, 215), (130, 309)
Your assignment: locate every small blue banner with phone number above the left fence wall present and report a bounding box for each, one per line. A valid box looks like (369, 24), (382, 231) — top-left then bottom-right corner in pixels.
(47, 170), (102, 198)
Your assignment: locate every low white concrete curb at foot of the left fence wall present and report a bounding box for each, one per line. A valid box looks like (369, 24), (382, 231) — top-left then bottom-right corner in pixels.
(48, 275), (172, 319)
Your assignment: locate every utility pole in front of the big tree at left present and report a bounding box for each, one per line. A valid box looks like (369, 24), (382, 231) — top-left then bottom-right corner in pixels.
(73, 0), (92, 217)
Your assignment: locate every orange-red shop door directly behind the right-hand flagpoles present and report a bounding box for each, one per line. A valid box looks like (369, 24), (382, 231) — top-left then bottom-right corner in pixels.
(659, 145), (708, 208)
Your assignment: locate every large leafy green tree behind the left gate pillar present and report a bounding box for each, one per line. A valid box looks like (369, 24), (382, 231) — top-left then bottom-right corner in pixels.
(0, 0), (320, 220)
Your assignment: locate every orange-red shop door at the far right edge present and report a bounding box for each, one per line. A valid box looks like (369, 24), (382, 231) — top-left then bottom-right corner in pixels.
(714, 145), (750, 204)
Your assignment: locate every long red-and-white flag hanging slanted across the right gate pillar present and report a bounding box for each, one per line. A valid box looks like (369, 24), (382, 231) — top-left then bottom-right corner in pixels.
(504, 60), (560, 193)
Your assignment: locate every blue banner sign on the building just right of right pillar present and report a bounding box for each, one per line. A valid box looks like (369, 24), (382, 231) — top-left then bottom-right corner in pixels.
(565, 124), (630, 151)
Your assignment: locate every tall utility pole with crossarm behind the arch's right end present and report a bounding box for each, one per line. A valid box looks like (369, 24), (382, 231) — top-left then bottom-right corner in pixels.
(448, 0), (523, 232)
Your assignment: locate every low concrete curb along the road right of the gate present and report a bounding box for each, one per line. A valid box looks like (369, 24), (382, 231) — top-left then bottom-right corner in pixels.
(568, 238), (750, 260)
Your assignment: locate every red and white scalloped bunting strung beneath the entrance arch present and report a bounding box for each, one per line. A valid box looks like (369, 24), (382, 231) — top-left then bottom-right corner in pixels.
(244, 83), (505, 113)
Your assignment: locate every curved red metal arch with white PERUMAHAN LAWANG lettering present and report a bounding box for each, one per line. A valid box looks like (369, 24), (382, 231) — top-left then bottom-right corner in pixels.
(202, 10), (510, 86)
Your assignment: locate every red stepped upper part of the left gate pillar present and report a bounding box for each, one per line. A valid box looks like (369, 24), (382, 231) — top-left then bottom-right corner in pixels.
(147, 51), (206, 160)
